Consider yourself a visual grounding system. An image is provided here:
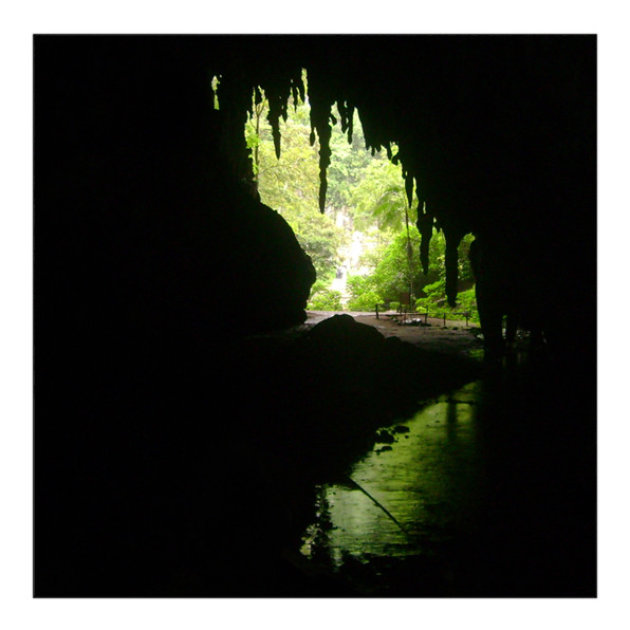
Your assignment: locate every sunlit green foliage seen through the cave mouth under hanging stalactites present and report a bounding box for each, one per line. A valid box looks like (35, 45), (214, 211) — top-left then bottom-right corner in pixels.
(245, 71), (421, 312)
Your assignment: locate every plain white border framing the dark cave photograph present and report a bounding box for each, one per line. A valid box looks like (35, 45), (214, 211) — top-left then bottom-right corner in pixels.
(0, 0), (630, 630)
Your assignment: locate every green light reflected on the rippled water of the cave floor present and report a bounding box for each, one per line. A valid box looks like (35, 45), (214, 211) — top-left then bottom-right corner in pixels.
(301, 382), (483, 567)
